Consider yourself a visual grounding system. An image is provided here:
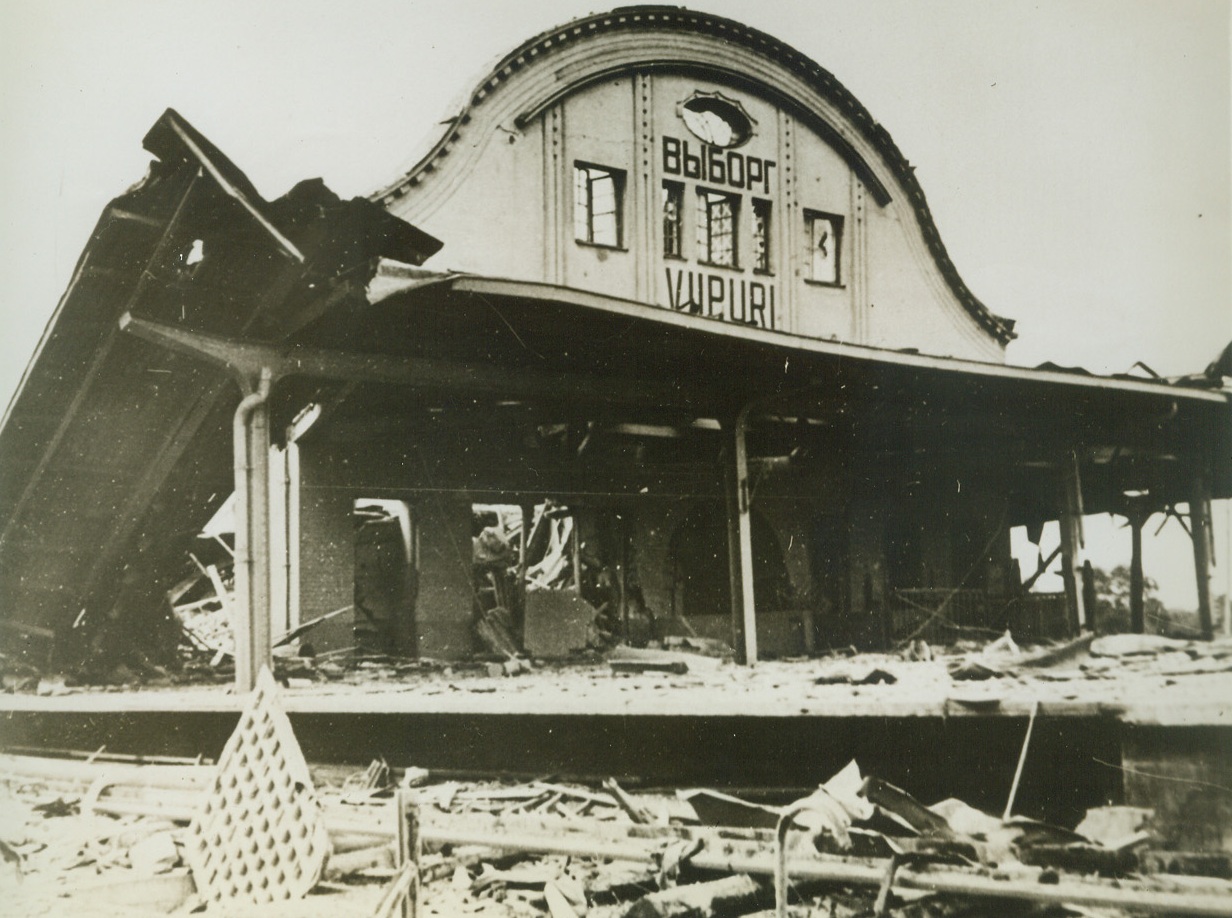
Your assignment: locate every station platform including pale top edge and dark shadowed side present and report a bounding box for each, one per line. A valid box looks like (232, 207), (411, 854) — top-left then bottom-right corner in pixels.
(0, 657), (1232, 824)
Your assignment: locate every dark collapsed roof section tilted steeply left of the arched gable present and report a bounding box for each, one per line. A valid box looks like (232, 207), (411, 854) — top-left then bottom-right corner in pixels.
(0, 110), (441, 650)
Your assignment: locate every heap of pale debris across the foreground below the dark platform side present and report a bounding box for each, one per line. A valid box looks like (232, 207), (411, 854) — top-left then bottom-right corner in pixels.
(0, 755), (1232, 918)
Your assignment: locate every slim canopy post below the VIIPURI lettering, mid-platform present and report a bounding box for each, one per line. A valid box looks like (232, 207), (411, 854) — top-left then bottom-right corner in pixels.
(723, 407), (758, 665)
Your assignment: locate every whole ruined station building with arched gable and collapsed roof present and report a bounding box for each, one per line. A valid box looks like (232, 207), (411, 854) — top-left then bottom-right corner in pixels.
(0, 7), (1232, 867)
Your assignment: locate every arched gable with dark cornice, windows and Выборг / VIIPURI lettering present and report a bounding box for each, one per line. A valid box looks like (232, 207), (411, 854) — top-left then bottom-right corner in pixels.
(375, 7), (1013, 362)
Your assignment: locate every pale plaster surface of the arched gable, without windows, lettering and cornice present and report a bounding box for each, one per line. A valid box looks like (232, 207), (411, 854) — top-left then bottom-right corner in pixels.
(379, 36), (1004, 362)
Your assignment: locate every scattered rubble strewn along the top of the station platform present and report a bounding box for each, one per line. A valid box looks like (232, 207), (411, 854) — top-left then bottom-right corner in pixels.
(9, 611), (1232, 695)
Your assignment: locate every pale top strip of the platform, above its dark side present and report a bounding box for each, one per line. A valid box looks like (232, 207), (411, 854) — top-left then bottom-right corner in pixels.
(0, 654), (1232, 727)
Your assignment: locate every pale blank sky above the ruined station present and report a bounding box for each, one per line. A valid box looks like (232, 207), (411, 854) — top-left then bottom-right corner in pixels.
(0, 0), (1232, 604)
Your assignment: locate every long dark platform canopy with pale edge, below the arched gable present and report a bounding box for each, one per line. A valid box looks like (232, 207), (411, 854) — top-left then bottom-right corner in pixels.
(299, 265), (1232, 522)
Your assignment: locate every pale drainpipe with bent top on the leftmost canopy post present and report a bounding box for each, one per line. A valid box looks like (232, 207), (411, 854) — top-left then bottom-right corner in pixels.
(232, 367), (274, 694)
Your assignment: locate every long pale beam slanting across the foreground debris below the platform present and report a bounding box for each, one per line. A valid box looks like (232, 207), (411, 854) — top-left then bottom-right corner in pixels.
(0, 755), (1232, 917)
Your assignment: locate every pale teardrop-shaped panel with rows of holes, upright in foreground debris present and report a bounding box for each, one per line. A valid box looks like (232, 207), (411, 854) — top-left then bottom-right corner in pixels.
(187, 669), (330, 904)
